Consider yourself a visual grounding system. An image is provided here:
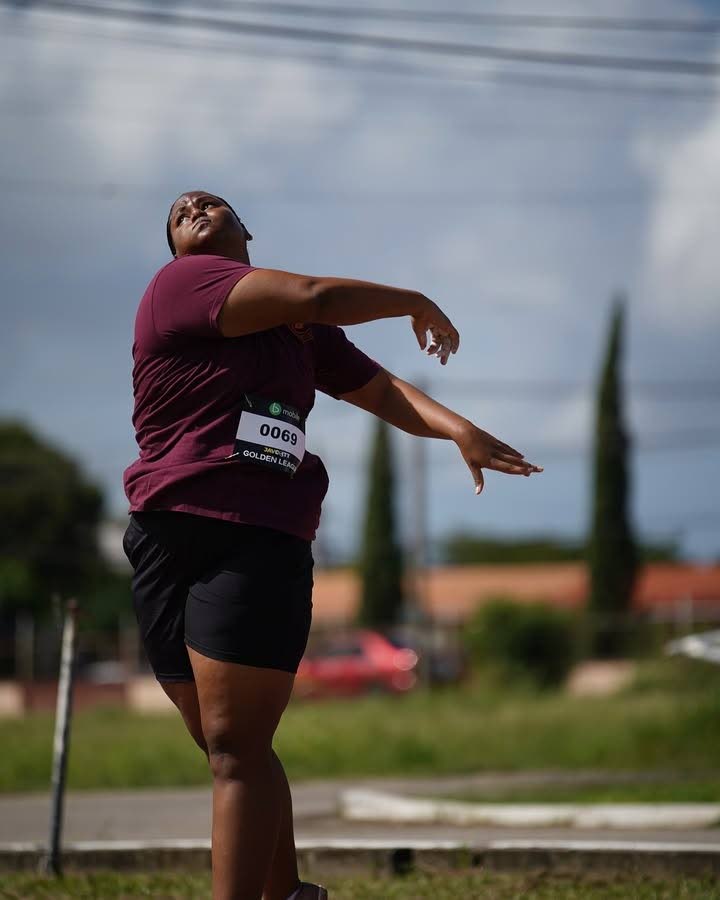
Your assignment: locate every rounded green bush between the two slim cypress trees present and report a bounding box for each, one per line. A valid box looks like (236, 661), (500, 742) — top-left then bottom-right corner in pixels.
(465, 599), (576, 687)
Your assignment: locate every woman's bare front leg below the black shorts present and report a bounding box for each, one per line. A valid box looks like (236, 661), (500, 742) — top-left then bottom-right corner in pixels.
(189, 649), (299, 900)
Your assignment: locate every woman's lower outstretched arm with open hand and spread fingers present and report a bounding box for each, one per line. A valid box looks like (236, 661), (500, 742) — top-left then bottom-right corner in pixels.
(342, 369), (542, 494)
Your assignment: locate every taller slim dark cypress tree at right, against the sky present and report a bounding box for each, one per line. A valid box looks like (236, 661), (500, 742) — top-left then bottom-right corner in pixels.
(588, 297), (638, 656)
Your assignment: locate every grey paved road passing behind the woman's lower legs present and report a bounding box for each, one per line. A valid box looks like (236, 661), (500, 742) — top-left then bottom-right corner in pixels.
(0, 773), (720, 850)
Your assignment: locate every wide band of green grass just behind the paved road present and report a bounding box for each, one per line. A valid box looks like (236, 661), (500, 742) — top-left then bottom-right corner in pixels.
(0, 659), (720, 800)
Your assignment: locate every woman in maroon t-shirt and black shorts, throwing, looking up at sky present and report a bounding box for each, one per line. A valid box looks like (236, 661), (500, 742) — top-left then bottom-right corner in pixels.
(124, 191), (541, 900)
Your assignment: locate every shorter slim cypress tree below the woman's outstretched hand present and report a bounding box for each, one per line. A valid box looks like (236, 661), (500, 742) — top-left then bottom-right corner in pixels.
(358, 419), (403, 628)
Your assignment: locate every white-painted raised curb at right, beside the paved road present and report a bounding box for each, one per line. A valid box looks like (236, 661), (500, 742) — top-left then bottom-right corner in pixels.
(339, 789), (720, 829)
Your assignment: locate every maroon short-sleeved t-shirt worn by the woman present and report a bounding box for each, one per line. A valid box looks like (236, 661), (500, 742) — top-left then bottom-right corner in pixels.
(124, 255), (380, 540)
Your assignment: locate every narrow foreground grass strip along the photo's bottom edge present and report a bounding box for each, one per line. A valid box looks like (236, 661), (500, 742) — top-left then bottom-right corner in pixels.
(0, 870), (720, 900)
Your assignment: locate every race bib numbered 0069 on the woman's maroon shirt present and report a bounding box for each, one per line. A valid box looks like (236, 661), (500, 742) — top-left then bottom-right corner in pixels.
(227, 394), (305, 476)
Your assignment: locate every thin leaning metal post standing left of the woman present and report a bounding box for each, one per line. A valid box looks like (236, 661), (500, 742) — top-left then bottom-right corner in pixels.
(44, 600), (78, 875)
